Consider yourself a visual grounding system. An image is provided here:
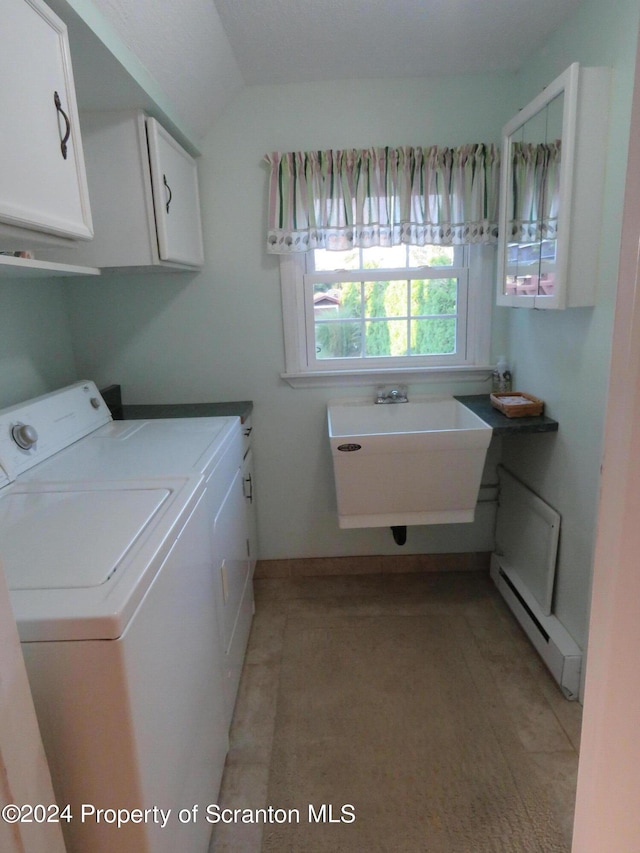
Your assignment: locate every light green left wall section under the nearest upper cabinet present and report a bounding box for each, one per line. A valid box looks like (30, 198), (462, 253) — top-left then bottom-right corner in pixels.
(0, 278), (76, 408)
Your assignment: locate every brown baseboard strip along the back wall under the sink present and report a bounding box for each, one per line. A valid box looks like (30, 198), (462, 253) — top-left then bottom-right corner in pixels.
(254, 551), (491, 578)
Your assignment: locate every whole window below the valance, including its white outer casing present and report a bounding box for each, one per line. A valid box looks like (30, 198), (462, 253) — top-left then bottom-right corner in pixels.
(280, 245), (494, 384)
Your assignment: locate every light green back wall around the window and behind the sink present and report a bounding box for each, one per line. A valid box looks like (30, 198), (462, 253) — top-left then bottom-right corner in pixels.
(63, 76), (514, 558)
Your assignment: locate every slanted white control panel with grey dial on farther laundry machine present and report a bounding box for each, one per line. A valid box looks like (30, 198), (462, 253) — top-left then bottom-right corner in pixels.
(0, 381), (112, 480)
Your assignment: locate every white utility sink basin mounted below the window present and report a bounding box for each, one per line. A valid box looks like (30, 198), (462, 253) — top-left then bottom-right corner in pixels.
(327, 397), (492, 527)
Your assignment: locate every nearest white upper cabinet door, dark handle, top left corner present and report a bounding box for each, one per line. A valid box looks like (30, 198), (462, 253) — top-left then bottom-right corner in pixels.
(0, 0), (93, 243)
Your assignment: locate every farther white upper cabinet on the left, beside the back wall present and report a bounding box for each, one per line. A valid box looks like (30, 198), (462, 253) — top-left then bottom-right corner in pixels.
(48, 110), (204, 270)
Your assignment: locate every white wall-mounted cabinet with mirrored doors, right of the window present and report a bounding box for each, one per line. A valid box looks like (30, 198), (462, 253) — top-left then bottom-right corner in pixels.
(497, 62), (610, 308)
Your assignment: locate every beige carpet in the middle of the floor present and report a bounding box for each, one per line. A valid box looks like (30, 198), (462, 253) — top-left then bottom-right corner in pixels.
(262, 614), (569, 853)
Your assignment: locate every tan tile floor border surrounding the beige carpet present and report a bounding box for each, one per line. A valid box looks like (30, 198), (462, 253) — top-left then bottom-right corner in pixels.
(210, 571), (581, 853)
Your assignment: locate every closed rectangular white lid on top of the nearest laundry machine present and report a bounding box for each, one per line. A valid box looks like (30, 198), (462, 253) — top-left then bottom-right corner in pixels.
(0, 487), (170, 590)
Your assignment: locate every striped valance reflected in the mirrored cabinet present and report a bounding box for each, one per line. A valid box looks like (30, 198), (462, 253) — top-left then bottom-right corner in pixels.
(507, 139), (561, 243)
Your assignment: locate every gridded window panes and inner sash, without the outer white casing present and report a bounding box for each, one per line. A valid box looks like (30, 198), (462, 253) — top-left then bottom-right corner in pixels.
(304, 245), (468, 367)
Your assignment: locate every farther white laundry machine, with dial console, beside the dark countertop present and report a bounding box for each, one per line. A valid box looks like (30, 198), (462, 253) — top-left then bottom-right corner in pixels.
(5, 382), (254, 725)
